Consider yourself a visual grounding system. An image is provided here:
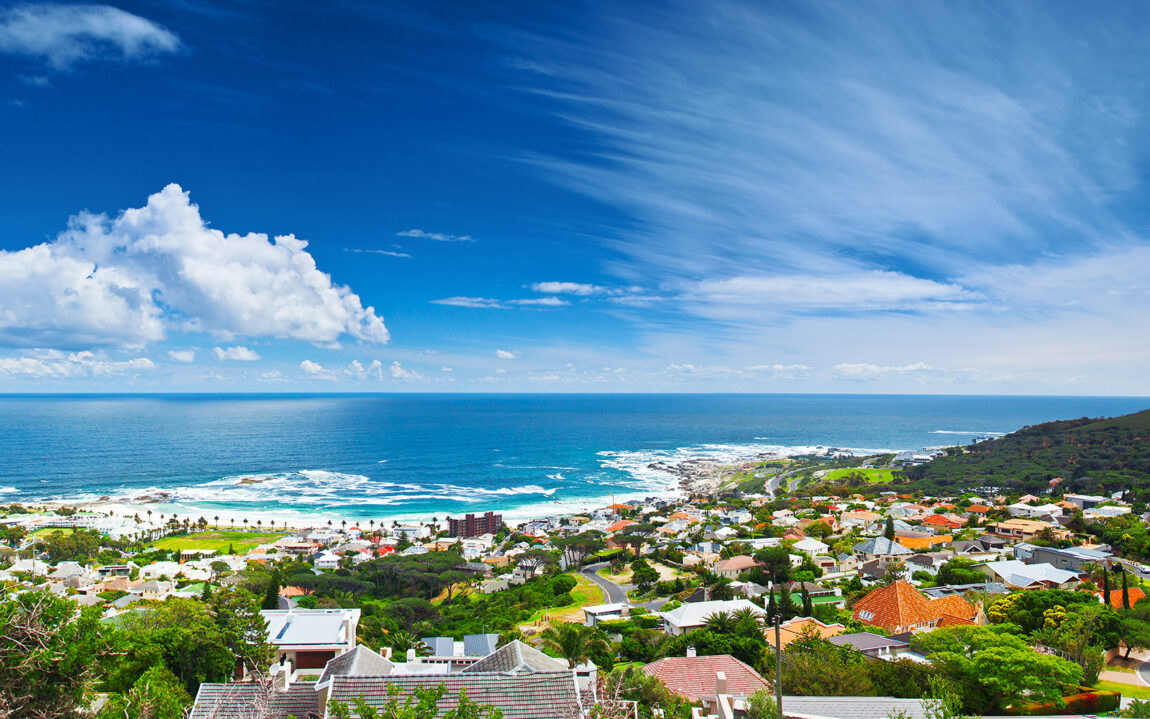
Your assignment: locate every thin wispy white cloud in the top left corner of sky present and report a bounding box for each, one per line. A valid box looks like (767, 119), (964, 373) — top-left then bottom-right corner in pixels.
(0, 2), (183, 70)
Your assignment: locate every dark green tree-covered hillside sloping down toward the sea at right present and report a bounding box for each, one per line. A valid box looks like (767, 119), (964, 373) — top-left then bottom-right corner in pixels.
(904, 410), (1150, 495)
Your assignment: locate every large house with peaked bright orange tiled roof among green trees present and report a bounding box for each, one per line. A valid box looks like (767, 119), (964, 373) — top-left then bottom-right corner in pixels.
(851, 580), (978, 634)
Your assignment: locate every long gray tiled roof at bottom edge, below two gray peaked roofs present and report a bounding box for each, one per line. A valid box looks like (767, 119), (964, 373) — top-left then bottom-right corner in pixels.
(328, 671), (580, 719)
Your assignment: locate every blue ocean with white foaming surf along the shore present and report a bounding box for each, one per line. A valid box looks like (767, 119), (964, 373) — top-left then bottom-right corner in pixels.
(0, 395), (1150, 523)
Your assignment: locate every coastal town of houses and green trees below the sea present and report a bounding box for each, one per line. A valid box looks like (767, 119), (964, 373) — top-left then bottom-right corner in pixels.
(0, 413), (1150, 719)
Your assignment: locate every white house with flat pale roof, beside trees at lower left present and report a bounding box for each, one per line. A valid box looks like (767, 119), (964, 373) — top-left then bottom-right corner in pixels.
(260, 607), (360, 668)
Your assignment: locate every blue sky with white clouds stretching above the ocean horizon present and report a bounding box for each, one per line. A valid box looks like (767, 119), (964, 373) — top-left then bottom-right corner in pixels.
(0, 0), (1150, 396)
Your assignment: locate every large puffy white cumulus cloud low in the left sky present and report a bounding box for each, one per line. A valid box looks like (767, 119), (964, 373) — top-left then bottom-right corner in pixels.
(0, 184), (389, 349)
